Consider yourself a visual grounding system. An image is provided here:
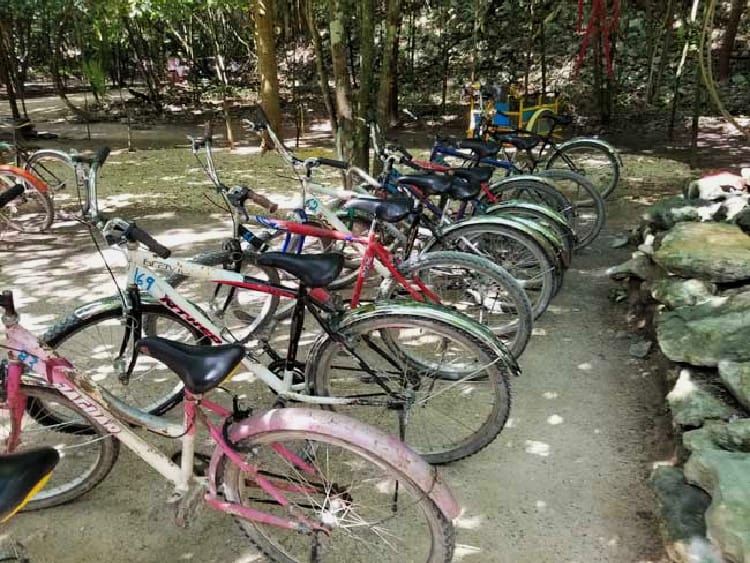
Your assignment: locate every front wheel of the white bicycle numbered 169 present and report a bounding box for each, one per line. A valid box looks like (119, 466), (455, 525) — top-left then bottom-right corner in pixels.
(40, 298), (209, 417)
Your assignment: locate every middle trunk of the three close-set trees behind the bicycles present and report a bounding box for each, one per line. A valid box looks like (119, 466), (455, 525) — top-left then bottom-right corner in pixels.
(353, 0), (375, 171)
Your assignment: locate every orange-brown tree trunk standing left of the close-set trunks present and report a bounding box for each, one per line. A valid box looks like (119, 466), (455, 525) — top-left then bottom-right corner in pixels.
(255, 0), (284, 141)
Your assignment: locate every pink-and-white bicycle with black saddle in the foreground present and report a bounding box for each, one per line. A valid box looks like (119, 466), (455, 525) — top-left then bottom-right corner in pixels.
(0, 291), (458, 563)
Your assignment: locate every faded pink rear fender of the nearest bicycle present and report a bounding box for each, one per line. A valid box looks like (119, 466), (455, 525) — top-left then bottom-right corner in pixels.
(209, 408), (461, 520)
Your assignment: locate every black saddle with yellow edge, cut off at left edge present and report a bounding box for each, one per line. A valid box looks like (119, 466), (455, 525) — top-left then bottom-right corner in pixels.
(0, 448), (60, 522)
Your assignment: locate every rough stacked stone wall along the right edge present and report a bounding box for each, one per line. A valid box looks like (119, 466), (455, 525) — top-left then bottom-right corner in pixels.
(609, 177), (750, 563)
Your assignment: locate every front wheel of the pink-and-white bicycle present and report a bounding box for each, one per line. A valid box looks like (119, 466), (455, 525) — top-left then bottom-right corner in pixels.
(0, 385), (120, 510)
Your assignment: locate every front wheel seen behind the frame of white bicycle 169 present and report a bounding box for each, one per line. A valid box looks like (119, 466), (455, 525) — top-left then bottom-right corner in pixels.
(166, 250), (279, 342)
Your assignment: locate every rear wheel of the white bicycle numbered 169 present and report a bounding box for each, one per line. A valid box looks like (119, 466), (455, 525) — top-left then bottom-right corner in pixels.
(306, 310), (511, 463)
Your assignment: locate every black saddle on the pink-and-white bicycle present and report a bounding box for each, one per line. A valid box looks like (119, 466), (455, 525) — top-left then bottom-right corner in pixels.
(135, 336), (245, 395)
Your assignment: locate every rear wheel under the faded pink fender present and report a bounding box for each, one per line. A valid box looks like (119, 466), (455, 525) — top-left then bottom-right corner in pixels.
(220, 429), (455, 563)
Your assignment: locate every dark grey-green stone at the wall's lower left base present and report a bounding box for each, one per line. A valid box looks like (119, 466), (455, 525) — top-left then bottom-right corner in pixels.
(651, 465), (720, 563)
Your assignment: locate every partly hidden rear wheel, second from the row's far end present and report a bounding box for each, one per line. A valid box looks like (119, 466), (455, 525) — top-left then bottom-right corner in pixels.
(539, 168), (607, 249)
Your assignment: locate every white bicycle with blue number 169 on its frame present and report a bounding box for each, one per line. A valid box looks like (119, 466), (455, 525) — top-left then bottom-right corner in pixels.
(43, 208), (518, 463)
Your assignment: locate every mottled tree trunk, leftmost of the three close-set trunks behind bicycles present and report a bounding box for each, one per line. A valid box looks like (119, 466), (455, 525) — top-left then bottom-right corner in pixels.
(328, 0), (354, 161)
